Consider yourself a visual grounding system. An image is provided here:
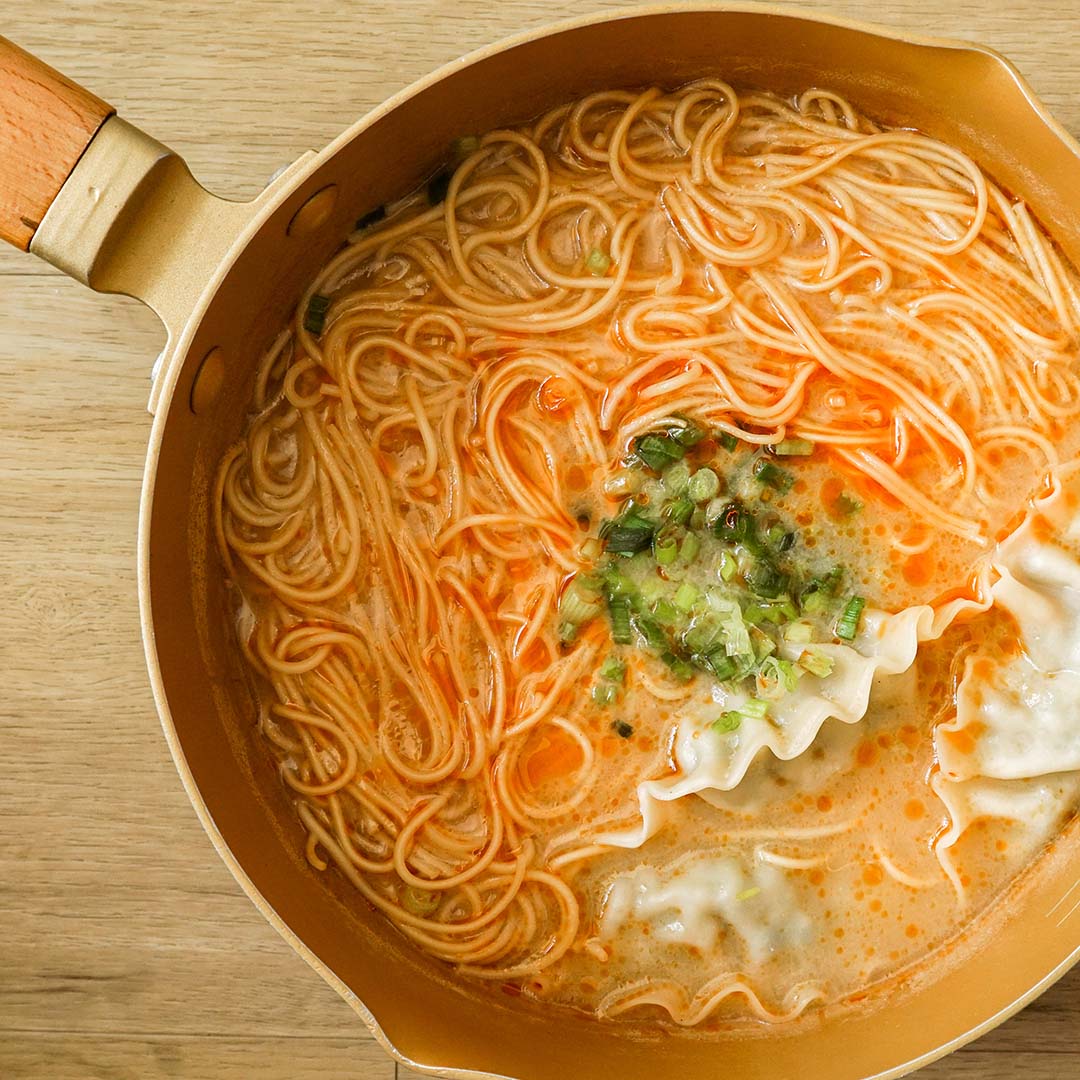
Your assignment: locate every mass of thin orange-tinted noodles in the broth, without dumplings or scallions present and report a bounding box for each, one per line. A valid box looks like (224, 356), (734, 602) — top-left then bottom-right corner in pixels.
(214, 79), (1080, 1025)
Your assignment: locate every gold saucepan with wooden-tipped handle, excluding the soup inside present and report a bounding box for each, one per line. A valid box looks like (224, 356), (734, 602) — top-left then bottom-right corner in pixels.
(0, 4), (1080, 1080)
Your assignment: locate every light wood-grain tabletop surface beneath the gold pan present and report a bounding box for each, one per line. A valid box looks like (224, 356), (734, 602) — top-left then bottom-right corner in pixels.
(0, 0), (1080, 1080)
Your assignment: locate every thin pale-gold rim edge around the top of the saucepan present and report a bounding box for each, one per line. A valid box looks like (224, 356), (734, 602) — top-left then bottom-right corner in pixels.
(137, 0), (1080, 1080)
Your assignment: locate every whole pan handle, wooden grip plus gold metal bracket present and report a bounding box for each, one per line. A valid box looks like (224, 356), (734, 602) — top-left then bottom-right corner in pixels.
(0, 37), (310, 350)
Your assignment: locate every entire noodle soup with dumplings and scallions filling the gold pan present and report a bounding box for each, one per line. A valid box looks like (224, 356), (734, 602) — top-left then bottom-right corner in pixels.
(216, 79), (1080, 1026)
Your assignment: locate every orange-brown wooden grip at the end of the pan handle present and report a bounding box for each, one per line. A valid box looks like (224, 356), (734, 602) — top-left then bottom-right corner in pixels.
(0, 38), (116, 252)
